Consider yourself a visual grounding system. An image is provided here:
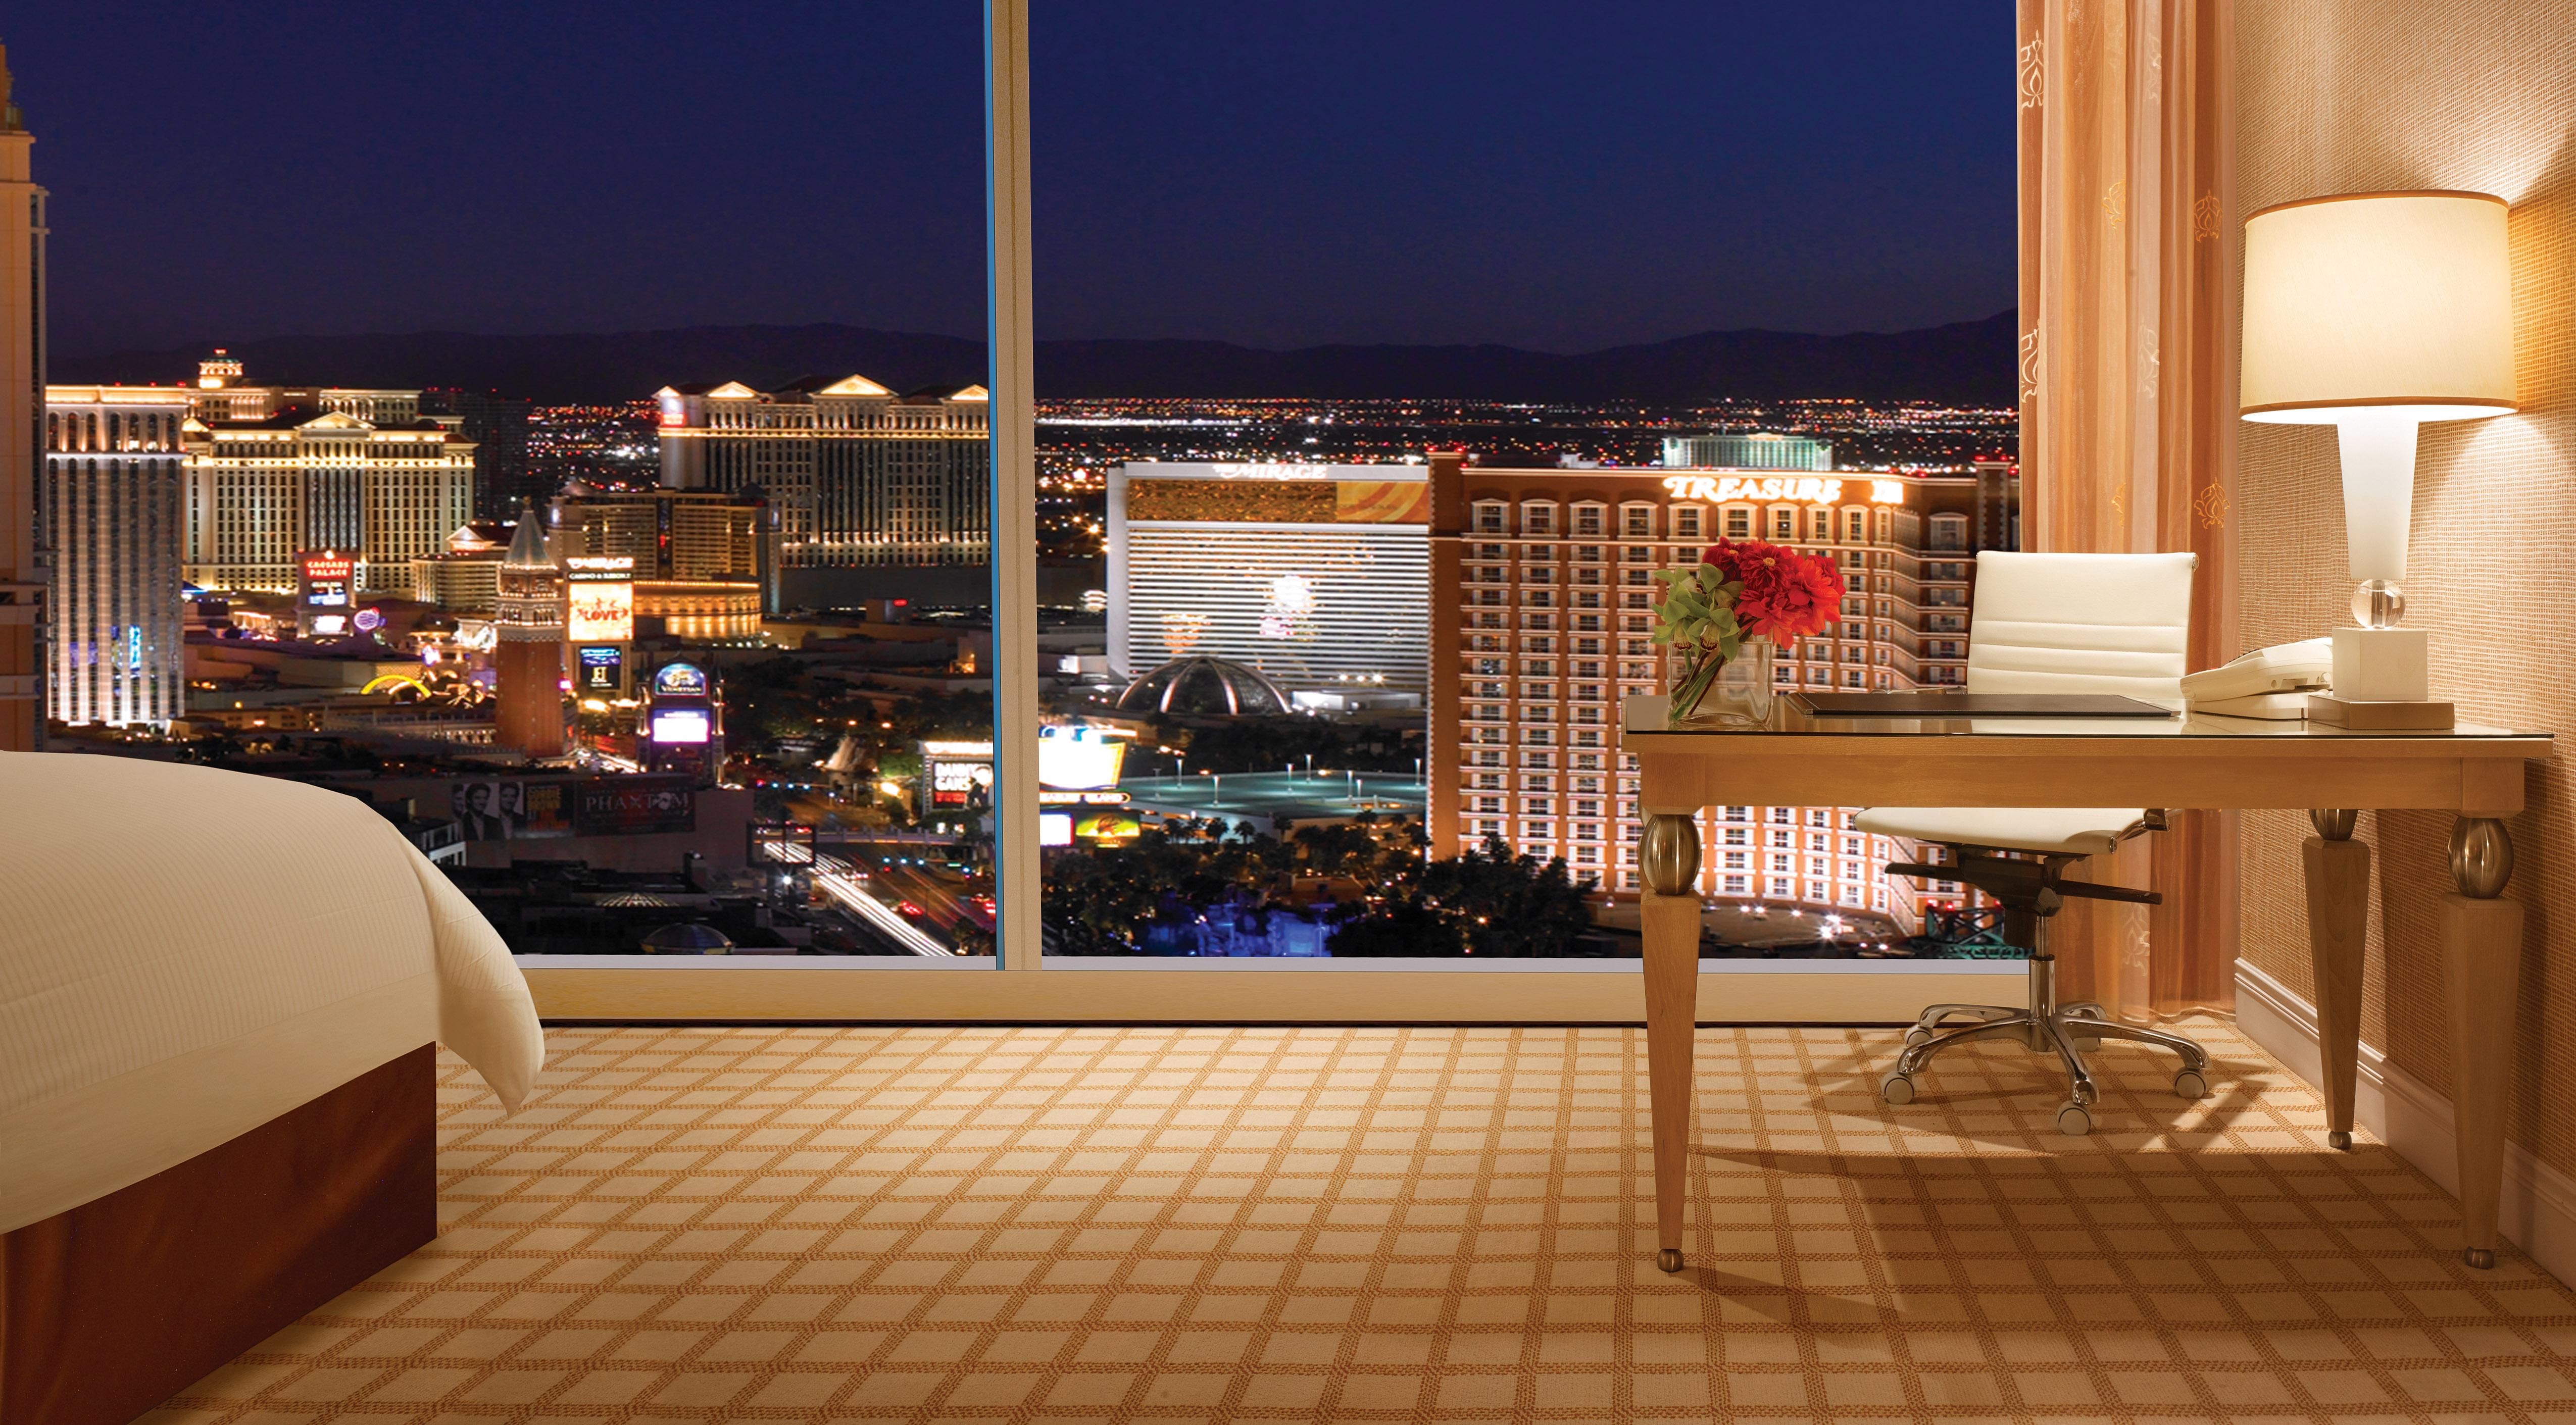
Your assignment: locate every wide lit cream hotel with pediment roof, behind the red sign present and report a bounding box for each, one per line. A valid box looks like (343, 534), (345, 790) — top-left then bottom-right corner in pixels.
(185, 350), (474, 593)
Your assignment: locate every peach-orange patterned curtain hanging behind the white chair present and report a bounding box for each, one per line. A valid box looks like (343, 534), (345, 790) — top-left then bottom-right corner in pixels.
(2017, 0), (2236, 1021)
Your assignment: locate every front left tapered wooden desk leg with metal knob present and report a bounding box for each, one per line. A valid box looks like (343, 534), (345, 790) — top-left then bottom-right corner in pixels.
(1639, 815), (1700, 1270)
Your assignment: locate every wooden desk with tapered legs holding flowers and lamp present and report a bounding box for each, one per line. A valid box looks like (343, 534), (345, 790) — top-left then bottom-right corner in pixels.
(1620, 696), (2550, 1270)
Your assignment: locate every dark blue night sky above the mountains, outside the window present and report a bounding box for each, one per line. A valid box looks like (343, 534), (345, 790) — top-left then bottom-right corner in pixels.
(0, 0), (2012, 353)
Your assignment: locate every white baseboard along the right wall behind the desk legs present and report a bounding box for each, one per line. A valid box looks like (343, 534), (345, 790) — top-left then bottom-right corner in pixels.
(2236, 961), (2576, 1283)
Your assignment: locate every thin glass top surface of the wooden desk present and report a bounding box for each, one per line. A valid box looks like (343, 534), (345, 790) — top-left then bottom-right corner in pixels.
(1620, 691), (2550, 742)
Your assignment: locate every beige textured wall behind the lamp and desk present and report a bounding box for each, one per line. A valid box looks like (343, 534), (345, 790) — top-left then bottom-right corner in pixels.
(2236, 0), (2576, 1173)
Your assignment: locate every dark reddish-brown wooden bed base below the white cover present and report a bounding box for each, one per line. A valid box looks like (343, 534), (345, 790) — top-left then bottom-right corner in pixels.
(0, 1044), (438, 1425)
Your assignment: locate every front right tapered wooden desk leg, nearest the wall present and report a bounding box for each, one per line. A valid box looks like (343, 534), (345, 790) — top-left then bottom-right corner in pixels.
(2442, 817), (2522, 1268)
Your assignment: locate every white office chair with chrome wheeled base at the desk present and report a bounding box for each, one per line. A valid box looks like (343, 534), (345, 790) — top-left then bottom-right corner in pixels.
(1860, 554), (2210, 1136)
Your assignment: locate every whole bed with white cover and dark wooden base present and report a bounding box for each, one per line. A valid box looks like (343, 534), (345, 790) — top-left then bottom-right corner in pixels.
(0, 752), (543, 1425)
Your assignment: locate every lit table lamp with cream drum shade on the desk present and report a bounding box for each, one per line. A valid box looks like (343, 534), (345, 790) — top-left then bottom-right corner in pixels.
(2239, 193), (2514, 727)
